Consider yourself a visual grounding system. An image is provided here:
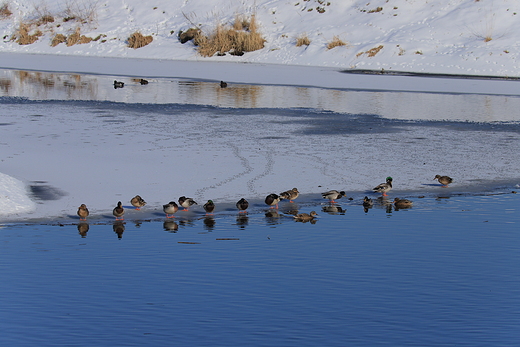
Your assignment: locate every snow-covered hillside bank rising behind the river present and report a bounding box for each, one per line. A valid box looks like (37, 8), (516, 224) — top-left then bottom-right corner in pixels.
(0, 0), (520, 76)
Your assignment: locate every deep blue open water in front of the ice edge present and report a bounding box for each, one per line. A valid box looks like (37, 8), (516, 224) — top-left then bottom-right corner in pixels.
(0, 194), (520, 346)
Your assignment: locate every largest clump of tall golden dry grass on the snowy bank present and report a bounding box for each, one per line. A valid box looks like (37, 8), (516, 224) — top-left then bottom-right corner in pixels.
(197, 15), (265, 57)
